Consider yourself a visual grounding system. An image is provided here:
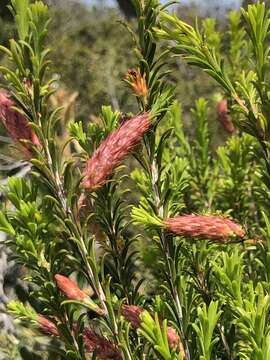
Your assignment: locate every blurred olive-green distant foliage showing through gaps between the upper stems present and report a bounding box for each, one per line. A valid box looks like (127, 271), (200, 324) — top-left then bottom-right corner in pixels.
(0, 0), (256, 123)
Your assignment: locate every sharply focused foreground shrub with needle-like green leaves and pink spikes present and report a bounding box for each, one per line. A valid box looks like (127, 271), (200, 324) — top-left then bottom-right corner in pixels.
(0, 0), (270, 360)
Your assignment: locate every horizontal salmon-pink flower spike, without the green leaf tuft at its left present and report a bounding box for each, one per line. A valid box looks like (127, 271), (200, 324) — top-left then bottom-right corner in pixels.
(164, 215), (245, 241)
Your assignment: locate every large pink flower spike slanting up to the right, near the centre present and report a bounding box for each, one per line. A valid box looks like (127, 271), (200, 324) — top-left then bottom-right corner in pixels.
(82, 113), (151, 191)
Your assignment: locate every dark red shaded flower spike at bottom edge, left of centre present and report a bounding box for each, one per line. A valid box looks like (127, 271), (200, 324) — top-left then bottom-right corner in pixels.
(83, 328), (122, 360)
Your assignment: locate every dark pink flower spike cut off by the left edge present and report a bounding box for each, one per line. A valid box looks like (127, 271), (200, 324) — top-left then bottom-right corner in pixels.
(0, 91), (40, 159)
